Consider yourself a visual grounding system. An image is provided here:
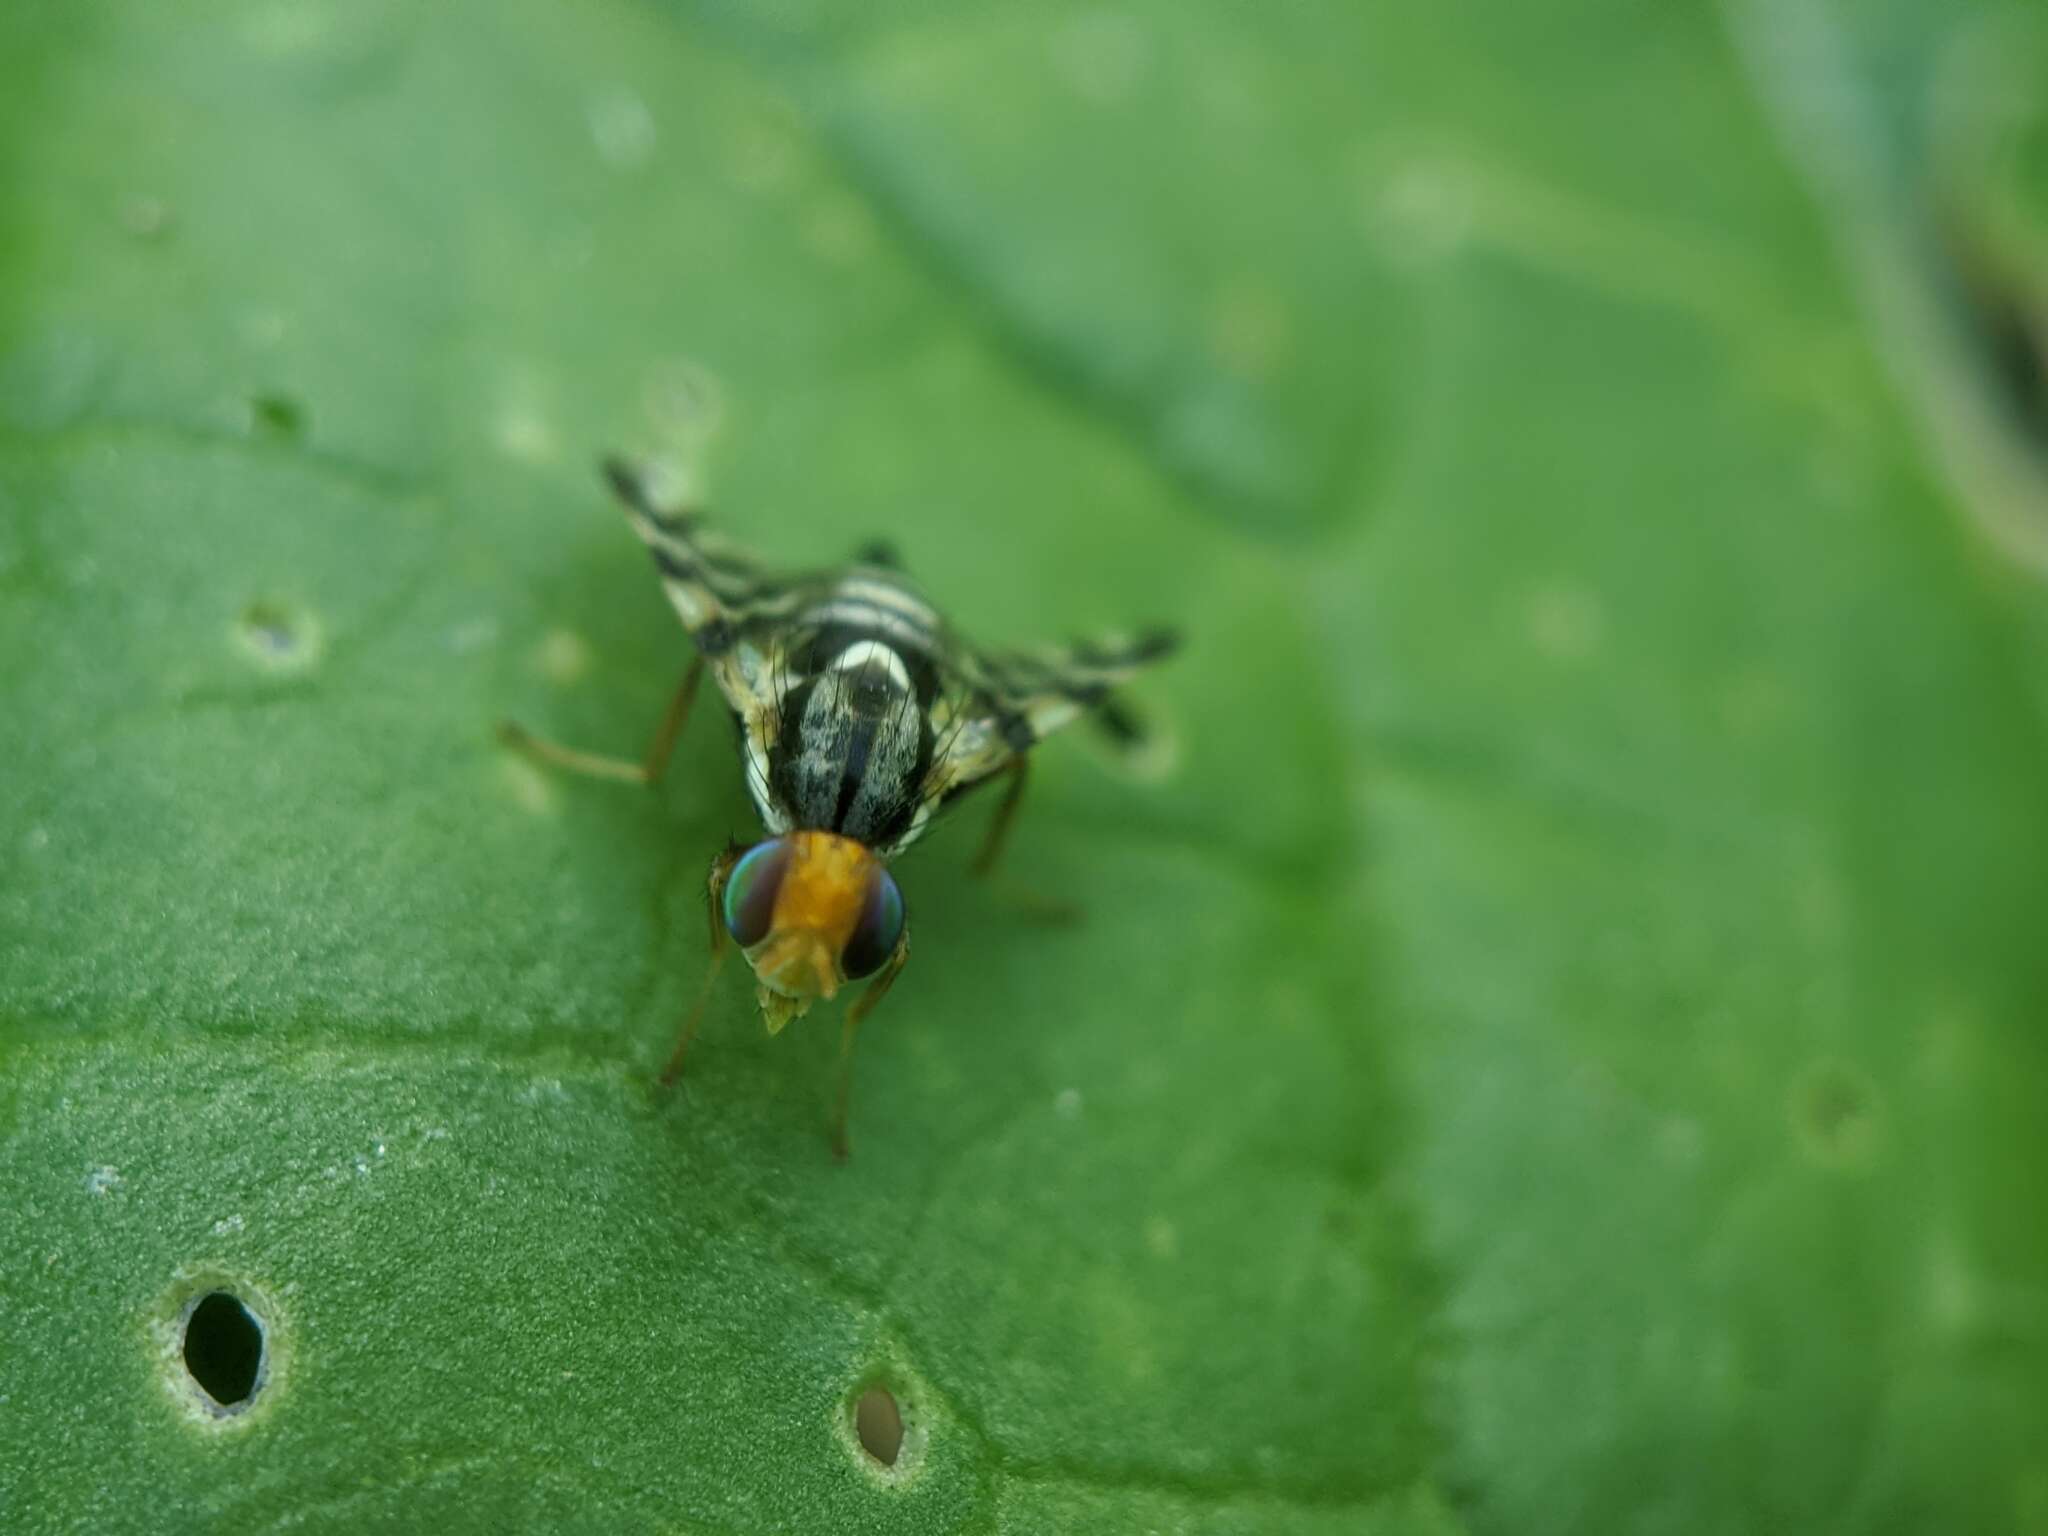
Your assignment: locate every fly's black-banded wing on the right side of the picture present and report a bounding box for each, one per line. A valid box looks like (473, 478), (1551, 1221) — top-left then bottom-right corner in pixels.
(926, 629), (1180, 819)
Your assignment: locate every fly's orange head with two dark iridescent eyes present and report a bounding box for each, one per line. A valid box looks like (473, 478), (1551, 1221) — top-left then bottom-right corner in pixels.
(723, 831), (903, 1030)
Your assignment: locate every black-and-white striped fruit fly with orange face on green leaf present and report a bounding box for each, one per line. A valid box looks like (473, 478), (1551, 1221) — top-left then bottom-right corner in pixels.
(500, 459), (1176, 1157)
